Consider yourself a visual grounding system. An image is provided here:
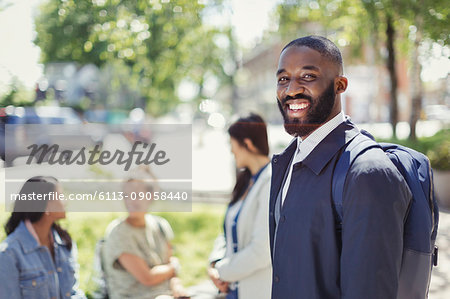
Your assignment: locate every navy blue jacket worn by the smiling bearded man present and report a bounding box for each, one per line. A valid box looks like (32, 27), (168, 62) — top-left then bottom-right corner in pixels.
(269, 121), (411, 299)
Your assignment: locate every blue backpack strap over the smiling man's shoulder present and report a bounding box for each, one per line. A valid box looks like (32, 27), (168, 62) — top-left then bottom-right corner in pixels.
(331, 132), (380, 230)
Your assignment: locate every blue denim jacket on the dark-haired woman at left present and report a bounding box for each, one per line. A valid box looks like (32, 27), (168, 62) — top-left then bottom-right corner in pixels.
(0, 222), (85, 299)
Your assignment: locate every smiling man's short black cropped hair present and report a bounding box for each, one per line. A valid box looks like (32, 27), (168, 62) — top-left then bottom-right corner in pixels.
(281, 35), (342, 70)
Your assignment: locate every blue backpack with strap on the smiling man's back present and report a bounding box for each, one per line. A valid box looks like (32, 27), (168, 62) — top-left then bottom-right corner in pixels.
(332, 130), (439, 299)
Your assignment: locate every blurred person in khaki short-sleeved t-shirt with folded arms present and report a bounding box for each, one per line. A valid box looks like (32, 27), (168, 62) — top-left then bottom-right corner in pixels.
(101, 169), (189, 299)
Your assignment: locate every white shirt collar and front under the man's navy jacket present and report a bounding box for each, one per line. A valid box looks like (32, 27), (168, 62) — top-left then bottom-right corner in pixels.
(281, 111), (345, 204)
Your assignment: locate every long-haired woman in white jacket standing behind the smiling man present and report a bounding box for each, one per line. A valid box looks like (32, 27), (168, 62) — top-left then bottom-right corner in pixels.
(208, 114), (272, 299)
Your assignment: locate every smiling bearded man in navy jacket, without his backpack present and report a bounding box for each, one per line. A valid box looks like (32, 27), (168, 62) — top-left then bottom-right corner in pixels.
(269, 36), (411, 299)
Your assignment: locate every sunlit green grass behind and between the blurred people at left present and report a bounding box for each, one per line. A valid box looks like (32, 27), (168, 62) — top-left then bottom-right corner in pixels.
(0, 203), (225, 294)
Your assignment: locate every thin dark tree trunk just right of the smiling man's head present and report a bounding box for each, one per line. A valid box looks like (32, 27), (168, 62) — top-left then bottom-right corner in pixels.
(386, 13), (398, 138)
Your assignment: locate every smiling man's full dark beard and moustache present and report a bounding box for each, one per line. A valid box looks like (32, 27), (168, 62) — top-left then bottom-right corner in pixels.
(277, 82), (336, 137)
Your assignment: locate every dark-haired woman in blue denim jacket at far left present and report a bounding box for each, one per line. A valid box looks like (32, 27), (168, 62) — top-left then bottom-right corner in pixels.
(0, 176), (85, 299)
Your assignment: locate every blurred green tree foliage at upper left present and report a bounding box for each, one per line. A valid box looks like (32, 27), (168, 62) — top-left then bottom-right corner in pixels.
(35, 0), (229, 115)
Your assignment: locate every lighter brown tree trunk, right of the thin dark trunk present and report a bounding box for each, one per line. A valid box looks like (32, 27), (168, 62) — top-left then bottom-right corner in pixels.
(409, 8), (423, 140)
